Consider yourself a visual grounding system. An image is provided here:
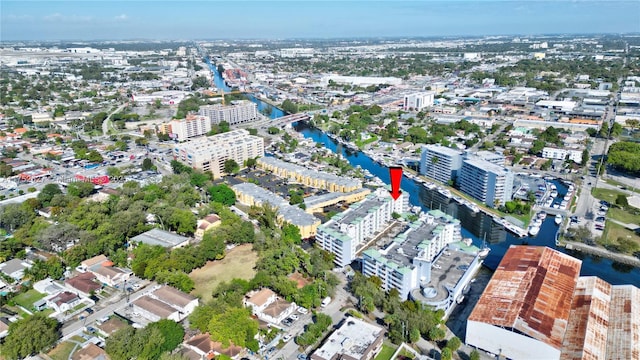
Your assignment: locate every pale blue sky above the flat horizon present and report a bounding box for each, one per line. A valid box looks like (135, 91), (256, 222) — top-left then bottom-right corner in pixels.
(0, 0), (640, 41)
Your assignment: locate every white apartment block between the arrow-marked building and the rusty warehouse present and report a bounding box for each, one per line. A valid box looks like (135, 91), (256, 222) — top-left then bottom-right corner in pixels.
(362, 210), (462, 299)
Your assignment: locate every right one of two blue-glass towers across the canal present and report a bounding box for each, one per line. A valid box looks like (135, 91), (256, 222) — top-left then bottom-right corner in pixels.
(458, 158), (514, 207)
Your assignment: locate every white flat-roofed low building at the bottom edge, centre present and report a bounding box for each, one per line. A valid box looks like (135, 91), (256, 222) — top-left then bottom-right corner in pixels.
(311, 317), (385, 360)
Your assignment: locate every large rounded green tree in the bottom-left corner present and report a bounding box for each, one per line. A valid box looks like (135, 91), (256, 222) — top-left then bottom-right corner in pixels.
(2, 314), (60, 359)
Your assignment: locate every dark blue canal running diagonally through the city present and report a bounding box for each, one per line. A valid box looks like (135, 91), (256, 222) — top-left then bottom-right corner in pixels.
(207, 56), (640, 287)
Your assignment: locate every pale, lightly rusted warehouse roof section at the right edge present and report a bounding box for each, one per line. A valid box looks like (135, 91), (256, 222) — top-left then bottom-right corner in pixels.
(606, 285), (640, 360)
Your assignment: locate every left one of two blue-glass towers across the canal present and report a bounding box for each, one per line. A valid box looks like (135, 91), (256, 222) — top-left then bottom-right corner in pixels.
(420, 145), (462, 184)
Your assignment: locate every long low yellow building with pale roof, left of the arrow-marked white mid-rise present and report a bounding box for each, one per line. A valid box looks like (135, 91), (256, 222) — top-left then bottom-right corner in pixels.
(232, 183), (320, 239)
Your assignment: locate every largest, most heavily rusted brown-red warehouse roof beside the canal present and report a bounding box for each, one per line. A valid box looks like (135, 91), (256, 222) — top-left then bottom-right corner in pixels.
(469, 245), (582, 349)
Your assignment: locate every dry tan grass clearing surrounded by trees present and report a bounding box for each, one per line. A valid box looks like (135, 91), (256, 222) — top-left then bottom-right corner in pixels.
(189, 244), (258, 302)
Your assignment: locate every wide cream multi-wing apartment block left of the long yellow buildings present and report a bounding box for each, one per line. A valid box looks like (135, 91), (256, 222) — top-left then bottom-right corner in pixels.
(173, 129), (264, 178)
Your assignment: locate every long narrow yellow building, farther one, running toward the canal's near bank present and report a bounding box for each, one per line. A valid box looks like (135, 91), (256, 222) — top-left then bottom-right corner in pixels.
(257, 157), (362, 192)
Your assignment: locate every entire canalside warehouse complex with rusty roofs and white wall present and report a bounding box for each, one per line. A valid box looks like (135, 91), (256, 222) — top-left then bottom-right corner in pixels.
(466, 245), (640, 359)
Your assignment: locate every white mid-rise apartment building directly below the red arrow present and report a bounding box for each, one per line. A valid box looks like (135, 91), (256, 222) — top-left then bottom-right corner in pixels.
(316, 188), (409, 267)
